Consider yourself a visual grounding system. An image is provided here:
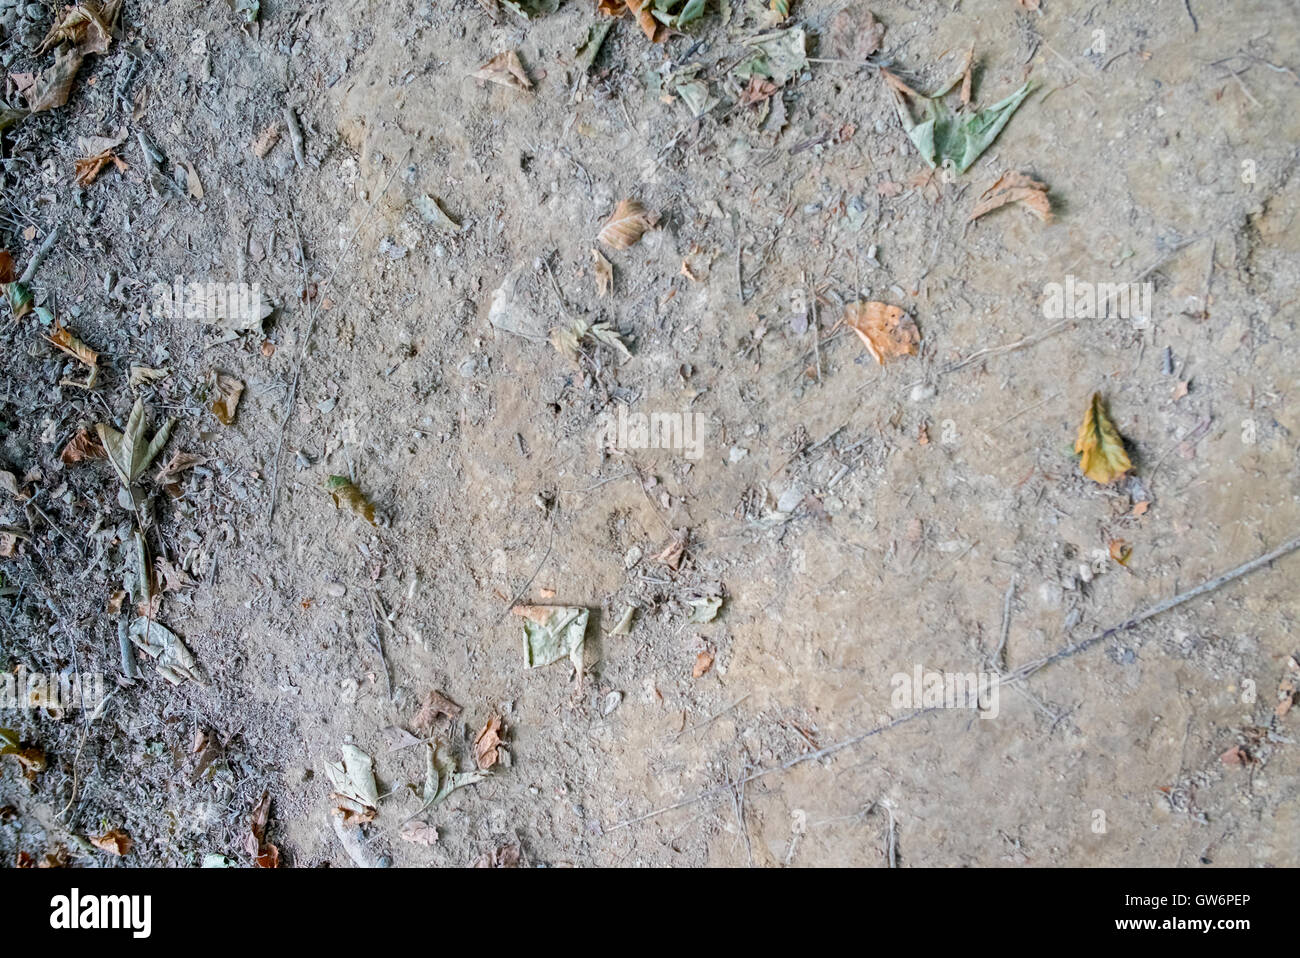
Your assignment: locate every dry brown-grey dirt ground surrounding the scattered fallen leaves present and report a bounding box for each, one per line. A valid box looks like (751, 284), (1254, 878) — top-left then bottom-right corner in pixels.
(0, 0), (1300, 867)
